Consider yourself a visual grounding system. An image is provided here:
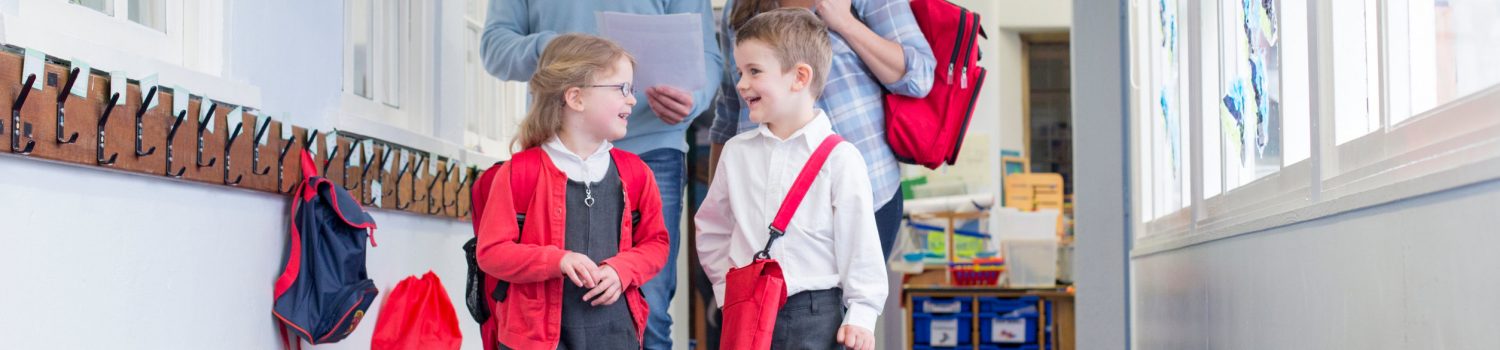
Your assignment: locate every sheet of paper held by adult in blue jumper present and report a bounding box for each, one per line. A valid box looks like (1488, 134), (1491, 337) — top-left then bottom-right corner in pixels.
(596, 12), (708, 92)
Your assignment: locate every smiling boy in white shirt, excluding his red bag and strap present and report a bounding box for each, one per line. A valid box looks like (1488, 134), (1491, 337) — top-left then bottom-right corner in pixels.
(695, 9), (887, 350)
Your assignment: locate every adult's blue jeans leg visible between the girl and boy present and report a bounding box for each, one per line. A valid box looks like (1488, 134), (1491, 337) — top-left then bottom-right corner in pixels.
(641, 149), (687, 350)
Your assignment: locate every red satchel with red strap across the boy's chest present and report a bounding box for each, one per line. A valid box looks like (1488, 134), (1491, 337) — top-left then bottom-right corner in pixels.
(719, 135), (843, 350)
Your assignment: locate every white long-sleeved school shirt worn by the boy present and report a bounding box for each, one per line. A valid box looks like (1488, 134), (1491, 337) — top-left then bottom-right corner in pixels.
(693, 110), (888, 330)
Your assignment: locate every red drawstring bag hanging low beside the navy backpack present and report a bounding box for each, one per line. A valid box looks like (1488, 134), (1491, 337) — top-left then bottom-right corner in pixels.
(371, 270), (464, 350)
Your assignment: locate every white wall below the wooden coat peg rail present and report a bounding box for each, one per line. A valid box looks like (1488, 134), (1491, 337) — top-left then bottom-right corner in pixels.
(0, 155), (479, 348)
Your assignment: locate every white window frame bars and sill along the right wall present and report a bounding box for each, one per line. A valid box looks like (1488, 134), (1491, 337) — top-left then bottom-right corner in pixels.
(1130, 0), (1500, 257)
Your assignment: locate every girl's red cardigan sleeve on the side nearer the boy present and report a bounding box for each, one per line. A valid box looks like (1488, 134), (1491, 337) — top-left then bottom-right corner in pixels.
(603, 159), (669, 288)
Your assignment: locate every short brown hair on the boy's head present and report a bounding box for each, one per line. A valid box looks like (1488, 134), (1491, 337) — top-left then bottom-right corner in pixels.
(735, 8), (834, 98)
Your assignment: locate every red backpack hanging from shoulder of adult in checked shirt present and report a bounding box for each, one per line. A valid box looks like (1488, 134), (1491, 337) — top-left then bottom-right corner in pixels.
(885, 0), (989, 168)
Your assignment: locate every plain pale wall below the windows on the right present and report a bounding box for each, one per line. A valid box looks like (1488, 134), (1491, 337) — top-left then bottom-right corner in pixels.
(1133, 182), (1500, 348)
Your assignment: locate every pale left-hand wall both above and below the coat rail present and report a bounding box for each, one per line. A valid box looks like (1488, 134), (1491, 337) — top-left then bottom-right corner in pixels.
(0, 0), (480, 350)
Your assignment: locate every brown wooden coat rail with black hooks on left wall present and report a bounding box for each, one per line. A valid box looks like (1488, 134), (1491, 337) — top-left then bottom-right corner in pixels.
(0, 45), (482, 219)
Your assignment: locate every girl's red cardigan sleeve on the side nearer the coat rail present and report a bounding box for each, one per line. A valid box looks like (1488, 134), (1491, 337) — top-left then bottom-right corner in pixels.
(474, 162), (567, 284)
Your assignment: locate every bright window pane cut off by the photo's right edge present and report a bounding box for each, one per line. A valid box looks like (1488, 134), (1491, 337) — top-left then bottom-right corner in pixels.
(1388, 0), (1500, 125)
